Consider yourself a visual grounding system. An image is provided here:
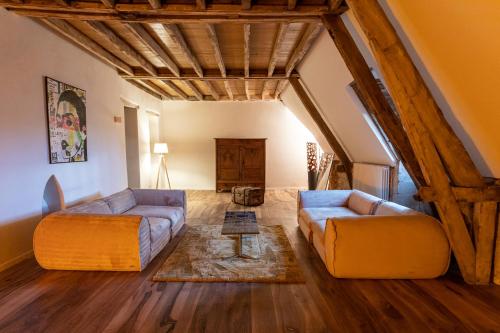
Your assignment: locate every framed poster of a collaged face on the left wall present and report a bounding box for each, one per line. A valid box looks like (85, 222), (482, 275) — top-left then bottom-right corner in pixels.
(45, 77), (87, 164)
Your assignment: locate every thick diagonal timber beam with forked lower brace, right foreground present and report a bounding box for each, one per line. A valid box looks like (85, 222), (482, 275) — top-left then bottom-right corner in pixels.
(347, 0), (483, 283)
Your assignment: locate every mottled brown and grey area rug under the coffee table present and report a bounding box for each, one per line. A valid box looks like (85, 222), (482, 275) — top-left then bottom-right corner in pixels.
(153, 225), (304, 283)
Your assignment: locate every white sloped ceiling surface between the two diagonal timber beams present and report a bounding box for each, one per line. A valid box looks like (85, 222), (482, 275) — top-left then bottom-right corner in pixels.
(282, 31), (394, 165)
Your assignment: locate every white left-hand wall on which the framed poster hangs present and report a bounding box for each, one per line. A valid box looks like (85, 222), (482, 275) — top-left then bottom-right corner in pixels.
(0, 9), (161, 270)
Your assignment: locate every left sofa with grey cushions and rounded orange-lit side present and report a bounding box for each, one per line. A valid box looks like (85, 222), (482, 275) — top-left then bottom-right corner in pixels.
(33, 189), (186, 271)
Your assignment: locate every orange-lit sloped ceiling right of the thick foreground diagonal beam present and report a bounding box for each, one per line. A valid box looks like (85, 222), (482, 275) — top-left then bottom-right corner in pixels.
(380, 0), (500, 178)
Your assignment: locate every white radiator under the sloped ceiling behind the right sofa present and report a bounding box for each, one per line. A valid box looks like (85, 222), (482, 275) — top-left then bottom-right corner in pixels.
(352, 163), (391, 200)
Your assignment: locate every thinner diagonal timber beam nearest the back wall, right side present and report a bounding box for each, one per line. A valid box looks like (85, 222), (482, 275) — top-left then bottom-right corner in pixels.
(289, 78), (352, 186)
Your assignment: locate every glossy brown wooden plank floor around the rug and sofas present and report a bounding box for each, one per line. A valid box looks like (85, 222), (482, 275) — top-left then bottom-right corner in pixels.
(0, 191), (500, 333)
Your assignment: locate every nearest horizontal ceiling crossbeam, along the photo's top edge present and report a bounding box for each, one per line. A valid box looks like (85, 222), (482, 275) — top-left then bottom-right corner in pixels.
(0, 0), (347, 24)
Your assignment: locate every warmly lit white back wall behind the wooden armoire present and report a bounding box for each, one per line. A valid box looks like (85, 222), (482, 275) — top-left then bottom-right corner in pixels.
(160, 101), (316, 189)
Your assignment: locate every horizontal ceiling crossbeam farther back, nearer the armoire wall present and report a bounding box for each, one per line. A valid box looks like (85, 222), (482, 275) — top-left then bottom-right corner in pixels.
(121, 67), (299, 81)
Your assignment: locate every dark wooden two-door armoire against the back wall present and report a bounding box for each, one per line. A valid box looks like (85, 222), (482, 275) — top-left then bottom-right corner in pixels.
(215, 138), (266, 192)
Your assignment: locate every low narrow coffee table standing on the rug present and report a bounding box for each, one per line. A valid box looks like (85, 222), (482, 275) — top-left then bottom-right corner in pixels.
(221, 211), (259, 259)
